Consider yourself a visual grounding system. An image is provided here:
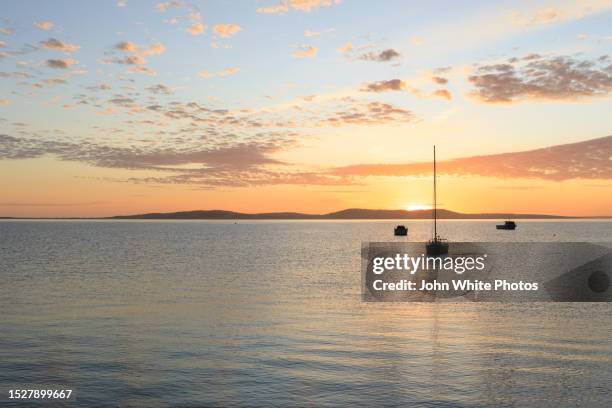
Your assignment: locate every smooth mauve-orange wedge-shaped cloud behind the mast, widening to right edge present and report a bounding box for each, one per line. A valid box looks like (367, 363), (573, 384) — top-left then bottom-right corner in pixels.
(331, 136), (612, 181)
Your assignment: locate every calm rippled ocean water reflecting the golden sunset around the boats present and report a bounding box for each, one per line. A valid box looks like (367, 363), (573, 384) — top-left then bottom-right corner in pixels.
(0, 221), (612, 408)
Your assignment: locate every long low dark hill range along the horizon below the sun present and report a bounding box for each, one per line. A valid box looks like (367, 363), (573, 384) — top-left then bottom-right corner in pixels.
(109, 208), (581, 220)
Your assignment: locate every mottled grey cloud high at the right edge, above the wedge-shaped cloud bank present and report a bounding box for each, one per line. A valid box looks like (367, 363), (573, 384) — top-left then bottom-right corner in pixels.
(468, 54), (612, 103)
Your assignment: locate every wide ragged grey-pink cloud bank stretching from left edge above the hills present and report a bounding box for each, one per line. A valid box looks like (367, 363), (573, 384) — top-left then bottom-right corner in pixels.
(0, 132), (354, 188)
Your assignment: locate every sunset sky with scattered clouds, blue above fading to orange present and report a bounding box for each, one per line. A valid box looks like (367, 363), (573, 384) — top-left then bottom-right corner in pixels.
(0, 0), (612, 217)
